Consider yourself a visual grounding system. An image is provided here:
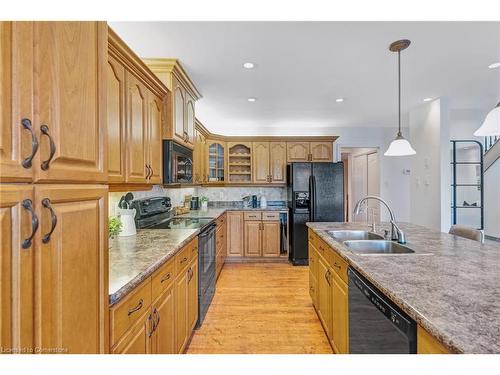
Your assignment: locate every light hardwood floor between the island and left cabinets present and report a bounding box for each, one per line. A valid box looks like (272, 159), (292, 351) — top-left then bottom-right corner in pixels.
(187, 263), (332, 354)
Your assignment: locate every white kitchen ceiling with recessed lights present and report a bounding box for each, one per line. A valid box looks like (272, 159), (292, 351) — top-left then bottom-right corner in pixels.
(110, 22), (500, 135)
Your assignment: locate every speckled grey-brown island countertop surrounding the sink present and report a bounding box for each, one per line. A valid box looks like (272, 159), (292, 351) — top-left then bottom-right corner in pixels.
(307, 223), (500, 353)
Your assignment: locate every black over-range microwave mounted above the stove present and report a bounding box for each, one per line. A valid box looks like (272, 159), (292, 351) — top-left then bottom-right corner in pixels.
(163, 140), (193, 184)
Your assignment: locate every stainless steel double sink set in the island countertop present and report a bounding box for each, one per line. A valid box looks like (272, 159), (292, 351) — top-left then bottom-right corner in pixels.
(328, 230), (415, 255)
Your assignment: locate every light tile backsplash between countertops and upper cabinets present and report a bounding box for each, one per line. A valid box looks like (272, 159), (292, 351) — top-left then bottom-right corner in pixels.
(108, 185), (286, 216)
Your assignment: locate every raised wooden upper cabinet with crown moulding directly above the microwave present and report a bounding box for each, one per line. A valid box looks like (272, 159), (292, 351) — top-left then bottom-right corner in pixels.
(144, 58), (201, 149)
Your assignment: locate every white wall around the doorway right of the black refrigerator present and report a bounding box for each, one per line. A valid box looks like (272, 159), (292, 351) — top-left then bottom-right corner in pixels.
(336, 124), (411, 221)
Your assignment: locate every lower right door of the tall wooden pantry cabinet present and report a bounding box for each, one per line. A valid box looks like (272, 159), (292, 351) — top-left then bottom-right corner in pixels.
(35, 185), (108, 353)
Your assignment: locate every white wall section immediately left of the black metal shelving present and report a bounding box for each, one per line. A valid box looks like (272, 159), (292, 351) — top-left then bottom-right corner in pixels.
(409, 99), (451, 232)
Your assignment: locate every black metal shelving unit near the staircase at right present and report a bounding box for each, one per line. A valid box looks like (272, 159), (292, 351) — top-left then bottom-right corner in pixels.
(450, 140), (484, 229)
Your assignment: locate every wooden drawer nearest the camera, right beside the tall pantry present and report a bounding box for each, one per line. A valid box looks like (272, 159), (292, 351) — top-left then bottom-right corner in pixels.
(110, 279), (151, 345)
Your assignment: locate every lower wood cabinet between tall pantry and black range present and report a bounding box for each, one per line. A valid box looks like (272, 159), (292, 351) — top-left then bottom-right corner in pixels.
(110, 239), (198, 354)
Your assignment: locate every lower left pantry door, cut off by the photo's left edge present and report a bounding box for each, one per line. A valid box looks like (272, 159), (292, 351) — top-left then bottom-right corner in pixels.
(0, 184), (36, 350)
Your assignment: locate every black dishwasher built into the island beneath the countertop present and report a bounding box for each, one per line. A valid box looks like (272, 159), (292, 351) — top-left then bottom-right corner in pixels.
(348, 268), (417, 354)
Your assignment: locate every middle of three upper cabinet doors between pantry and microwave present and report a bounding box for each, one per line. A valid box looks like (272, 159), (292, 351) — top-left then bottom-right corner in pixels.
(126, 72), (149, 184)
